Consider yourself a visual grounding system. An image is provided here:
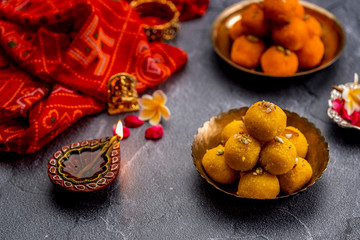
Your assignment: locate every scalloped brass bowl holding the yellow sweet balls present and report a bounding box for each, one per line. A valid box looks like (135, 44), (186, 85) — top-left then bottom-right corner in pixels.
(191, 107), (329, 199)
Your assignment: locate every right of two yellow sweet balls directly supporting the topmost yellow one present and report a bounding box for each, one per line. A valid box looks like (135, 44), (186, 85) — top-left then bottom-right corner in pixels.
(260, 136), (297, 175)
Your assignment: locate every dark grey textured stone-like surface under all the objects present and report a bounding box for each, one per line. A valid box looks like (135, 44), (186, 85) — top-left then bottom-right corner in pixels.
(0, 0), (360, 240)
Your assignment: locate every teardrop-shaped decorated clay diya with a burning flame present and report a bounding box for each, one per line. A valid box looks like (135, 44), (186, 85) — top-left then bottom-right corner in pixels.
(47, 121), (123, 192)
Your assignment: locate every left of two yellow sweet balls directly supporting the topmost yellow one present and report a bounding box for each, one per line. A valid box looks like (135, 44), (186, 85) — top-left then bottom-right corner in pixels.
(224, 133), (261, 171)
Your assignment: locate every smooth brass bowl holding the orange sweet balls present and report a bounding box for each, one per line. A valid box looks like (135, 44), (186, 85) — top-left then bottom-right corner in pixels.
(211, 0), (346, 78)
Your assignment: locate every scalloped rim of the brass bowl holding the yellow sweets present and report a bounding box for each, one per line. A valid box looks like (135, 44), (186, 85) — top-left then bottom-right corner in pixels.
(191, 106), (330, 201)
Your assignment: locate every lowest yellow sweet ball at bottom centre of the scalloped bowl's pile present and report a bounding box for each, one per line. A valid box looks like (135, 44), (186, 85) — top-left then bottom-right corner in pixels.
(236, 167), (280, 199)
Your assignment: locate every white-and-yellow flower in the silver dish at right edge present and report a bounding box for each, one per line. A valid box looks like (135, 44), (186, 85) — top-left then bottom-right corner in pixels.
(342, 73), (360, 115)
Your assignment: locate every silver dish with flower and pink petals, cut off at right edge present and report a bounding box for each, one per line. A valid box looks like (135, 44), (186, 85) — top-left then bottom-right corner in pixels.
(327, 73), (360, 130)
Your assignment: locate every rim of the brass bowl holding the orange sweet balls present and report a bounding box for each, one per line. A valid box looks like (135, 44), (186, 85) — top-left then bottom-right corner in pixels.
(210, 0), (346, 79)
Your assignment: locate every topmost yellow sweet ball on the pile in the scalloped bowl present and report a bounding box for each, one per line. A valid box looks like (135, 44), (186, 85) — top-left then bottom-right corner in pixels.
(244, 101), (287, 142)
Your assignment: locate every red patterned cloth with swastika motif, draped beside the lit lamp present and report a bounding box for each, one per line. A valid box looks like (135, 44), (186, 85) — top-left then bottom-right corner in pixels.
(0, 0), (194, 153)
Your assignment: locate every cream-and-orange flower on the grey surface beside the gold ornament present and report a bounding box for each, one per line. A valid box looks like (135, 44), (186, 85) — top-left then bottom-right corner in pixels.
(138, 90), (170, 126)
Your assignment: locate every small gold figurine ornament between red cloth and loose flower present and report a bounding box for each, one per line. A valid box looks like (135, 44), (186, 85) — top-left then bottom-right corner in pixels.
(107, 73), (139, 115)
